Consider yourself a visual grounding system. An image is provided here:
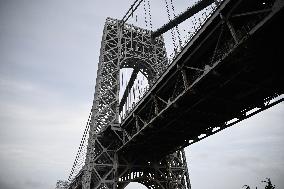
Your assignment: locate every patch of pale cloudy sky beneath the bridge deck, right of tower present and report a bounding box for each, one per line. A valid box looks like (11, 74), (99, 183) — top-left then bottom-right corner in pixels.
(186, 103), (284, 189)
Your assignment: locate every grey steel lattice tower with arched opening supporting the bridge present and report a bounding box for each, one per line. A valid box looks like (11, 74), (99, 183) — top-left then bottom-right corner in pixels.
(77, 18), (191, 189)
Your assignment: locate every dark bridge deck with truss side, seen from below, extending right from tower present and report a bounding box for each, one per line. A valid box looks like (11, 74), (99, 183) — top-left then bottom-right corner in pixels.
(118, 0), (284, 159)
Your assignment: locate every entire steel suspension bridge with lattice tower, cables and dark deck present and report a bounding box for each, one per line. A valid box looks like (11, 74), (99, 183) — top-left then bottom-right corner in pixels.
(57, 0), (284, 189)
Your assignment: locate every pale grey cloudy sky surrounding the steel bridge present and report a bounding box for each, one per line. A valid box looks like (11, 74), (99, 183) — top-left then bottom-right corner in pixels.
(0, 0), (284, 189)
